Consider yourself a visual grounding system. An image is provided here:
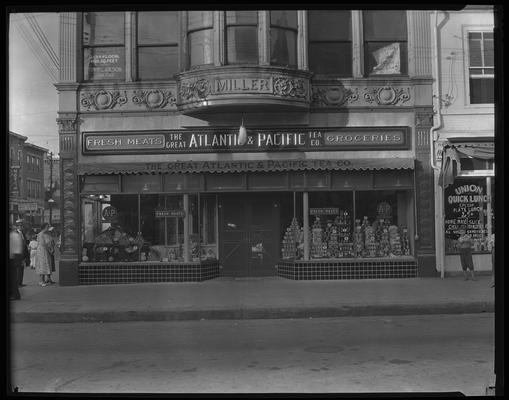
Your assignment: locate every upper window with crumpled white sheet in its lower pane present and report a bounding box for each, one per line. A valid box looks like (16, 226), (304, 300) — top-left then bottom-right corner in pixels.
(362, 10), (408, 76)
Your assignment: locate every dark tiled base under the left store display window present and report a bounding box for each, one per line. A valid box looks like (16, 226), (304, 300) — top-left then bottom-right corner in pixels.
(78, 261), (220, 285)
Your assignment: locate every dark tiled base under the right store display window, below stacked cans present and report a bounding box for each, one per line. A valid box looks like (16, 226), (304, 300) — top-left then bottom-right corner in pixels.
(276, 258), (417, 280)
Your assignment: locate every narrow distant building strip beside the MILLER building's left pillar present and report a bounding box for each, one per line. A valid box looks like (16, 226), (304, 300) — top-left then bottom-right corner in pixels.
(44, 153), (61, 228)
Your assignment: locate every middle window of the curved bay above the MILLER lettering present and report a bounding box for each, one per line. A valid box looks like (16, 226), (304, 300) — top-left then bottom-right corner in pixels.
(225, 11), (258, 64)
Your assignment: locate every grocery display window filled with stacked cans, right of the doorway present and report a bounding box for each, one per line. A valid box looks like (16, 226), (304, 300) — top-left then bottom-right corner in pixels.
(281, 190), (413, 260)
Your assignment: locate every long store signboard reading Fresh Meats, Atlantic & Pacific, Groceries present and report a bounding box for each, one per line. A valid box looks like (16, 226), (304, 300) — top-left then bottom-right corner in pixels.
(82, 127), (410, 154)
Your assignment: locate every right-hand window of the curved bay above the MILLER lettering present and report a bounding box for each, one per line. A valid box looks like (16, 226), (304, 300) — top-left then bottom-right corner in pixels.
(269, 10), (297, 68)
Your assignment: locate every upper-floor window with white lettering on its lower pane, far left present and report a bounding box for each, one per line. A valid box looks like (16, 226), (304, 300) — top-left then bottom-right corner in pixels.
(83, 12), (125, 81)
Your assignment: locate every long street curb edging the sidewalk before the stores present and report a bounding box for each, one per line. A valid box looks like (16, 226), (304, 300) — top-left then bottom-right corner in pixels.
(11, 302), (495, 323)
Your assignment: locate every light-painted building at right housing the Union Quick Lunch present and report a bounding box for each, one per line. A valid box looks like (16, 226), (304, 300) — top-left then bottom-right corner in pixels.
(431, 5), (495, 276)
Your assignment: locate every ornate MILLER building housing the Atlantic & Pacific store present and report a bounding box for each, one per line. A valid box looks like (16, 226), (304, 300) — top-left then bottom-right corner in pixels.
(56, 10), (437, 285)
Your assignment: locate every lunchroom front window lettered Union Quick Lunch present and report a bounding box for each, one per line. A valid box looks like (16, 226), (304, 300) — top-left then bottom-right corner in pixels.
(444, 178), (495, 254)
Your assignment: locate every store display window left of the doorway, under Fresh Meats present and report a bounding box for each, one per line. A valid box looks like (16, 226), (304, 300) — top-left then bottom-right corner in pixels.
(81, 194), (218, 262)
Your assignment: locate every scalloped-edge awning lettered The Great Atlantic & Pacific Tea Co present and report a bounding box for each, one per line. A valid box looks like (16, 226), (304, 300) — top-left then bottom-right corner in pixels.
(78, 158), (415, 175)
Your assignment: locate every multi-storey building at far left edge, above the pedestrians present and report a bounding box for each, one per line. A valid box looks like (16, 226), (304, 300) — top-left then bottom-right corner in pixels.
(9, 132), (48, 228)
